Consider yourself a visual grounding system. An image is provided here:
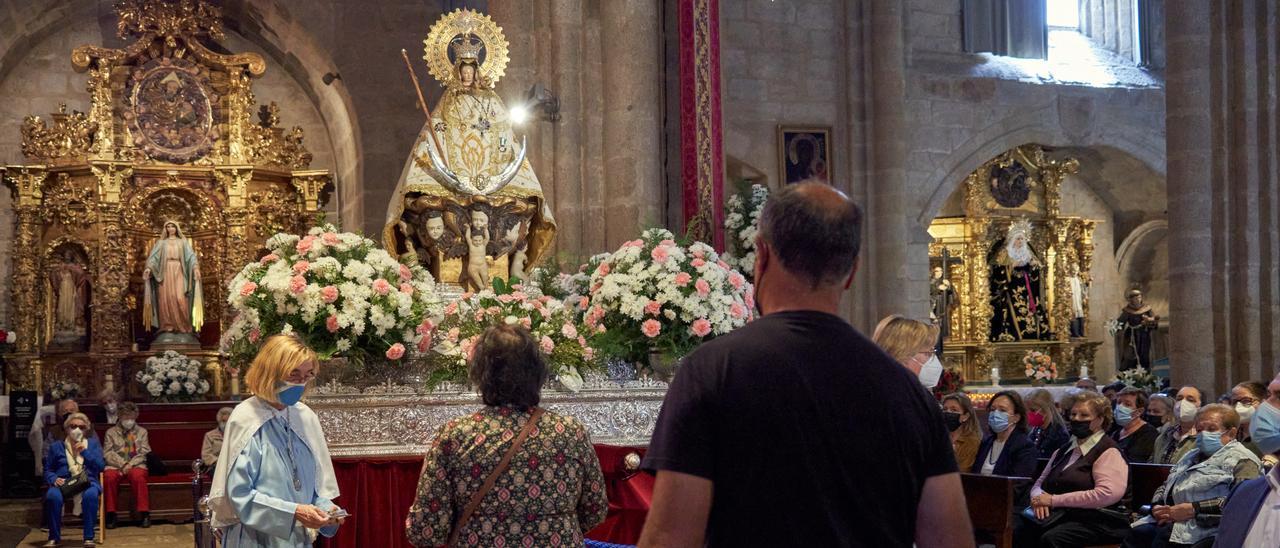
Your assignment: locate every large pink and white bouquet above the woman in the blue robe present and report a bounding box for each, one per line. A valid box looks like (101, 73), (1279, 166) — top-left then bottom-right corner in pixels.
(223, 224), (440, 365)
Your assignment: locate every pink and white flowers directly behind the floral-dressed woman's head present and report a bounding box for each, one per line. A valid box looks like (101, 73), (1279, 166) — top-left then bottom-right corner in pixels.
(429, 280), (596, 392)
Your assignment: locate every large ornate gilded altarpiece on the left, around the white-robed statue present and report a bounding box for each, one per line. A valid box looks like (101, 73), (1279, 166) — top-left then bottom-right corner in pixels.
(0, 0), (333, 394)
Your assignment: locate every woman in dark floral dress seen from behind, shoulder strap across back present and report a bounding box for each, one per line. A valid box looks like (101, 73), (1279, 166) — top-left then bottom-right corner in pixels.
(404, 325), (608, 547)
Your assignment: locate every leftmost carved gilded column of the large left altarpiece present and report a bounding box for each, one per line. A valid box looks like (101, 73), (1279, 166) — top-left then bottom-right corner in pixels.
(5, 165), (49, 353)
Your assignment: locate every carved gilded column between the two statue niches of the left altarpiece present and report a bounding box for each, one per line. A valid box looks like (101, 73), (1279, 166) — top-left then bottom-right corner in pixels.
(90, 161), (133, 352)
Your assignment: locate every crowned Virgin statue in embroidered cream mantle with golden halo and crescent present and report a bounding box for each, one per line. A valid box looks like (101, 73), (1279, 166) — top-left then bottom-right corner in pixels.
(383, 9), (556, 289)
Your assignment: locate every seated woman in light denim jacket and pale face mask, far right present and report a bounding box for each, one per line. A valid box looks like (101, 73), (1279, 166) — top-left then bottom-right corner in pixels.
(1124, 403), (1262, 548)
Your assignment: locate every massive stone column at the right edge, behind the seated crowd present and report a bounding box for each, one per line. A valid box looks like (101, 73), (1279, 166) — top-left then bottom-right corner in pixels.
(1165, 3), (1280, 393)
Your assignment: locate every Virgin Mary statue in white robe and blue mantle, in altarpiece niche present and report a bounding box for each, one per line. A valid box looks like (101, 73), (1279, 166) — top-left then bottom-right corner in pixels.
(142, 220), (205, 343)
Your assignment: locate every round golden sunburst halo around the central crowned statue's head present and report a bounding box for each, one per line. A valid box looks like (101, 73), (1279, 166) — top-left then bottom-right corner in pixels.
(422, 8), (511, 88)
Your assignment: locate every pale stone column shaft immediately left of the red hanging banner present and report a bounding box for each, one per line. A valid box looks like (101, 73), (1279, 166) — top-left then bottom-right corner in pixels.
(600, 0), (666, 250)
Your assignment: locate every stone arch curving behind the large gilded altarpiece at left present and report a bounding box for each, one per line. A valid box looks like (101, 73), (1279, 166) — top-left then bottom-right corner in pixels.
(0, 0), (364, 227)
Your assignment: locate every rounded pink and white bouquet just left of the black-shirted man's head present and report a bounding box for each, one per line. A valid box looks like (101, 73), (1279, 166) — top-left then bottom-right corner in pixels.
(584, 228), (754, 376)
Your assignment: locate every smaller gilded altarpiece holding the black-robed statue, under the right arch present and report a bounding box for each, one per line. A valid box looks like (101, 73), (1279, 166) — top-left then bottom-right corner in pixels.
(929, 145), (1101, 383)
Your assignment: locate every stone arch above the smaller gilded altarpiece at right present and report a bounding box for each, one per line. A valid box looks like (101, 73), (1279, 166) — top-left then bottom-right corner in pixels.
(916, 106), (1165, 227)
